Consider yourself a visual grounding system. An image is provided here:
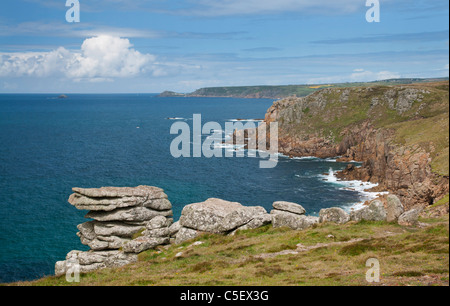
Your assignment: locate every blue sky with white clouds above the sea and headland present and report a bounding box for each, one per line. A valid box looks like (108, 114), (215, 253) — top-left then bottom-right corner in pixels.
(0, 0), (449, 93)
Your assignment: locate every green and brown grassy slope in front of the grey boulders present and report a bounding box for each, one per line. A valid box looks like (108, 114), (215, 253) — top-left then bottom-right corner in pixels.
(17, 216), (449, 286)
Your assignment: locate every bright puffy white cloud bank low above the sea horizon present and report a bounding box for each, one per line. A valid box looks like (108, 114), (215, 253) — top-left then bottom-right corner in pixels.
(0, 35), (161, 81)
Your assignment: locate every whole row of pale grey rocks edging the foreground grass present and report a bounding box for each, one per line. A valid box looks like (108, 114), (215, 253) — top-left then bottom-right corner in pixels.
(55, 186), (421, 276)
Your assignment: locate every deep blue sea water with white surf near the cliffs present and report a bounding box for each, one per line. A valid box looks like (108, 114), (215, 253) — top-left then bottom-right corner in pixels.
(0, 94), (370, 282)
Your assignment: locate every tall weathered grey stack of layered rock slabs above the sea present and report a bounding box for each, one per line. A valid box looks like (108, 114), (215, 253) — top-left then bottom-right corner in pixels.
(55, 186), (173, 275)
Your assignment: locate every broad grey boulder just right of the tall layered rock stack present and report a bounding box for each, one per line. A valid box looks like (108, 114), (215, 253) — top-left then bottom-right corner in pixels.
(175, 198), (270, 244)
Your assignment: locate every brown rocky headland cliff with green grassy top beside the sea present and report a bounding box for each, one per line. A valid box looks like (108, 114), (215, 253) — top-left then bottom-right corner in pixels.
(265, 82), (449, 208)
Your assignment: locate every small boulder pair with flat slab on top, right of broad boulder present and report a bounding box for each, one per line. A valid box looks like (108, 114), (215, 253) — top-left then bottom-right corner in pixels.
(270, 201), (319, 230)
